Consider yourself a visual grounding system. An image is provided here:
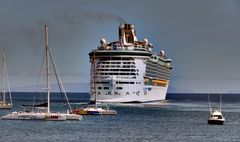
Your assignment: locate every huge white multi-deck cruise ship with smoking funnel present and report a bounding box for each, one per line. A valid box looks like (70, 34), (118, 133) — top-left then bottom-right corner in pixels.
(89, 24), (172, 103)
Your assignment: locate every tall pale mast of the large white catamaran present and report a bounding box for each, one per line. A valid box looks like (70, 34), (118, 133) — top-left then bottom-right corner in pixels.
(44, 25), (50, 113)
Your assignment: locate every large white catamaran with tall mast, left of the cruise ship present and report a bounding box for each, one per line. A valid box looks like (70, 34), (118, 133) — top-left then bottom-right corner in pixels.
(1, 25), (82, 121)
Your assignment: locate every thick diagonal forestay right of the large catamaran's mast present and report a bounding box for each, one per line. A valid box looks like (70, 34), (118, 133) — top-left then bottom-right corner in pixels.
(48, 48), (72, 112)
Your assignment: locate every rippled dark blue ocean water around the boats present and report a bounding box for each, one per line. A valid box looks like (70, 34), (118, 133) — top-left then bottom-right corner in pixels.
(0, 93), (240, 142)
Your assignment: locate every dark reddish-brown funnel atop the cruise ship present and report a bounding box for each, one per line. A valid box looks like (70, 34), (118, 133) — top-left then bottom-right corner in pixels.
(119, 24), (137, 45)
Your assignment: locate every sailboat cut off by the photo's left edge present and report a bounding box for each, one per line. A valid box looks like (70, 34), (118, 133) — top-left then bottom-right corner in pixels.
(0, 51), (13, 109)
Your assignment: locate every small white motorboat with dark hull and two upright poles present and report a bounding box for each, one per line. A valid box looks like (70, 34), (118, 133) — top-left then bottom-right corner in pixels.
(208, 95), (225, 125)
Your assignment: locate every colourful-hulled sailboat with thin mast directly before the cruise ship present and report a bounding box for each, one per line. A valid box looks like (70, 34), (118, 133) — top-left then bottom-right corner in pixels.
(72, 53), (117, 115)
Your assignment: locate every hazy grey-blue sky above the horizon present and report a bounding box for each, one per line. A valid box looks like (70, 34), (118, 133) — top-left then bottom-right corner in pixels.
(0, 0), (240, 93)
